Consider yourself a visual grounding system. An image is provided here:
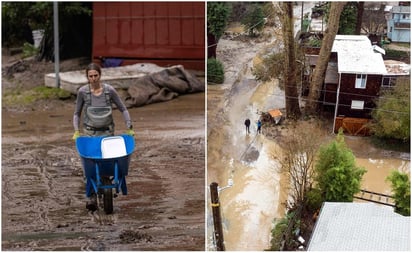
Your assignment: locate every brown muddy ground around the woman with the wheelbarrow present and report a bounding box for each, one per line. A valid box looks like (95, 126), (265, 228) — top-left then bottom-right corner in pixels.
(2, 54), (205, 251)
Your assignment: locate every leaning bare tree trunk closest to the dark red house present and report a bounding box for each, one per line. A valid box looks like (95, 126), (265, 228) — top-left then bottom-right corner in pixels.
(306, 2), (346, 114)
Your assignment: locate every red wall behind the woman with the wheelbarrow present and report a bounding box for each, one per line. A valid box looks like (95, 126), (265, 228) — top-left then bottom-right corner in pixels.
(92, 2), (205, 70)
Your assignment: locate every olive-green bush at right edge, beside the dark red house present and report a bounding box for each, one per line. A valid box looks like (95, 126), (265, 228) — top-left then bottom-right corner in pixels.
(371, 78), (411, 142)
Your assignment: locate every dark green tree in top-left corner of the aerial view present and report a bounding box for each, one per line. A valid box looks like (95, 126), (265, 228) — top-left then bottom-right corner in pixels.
(207, 2), (231, 40)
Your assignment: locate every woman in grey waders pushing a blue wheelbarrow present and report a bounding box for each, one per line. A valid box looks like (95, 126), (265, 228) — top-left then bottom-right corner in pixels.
(73, 63), (134, 214)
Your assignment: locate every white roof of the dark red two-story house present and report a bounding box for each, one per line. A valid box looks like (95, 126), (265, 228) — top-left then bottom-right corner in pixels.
(332, 35), (386, 75)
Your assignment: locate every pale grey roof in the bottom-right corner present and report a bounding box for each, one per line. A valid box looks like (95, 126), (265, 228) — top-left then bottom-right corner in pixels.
(308, 202), (411, 251)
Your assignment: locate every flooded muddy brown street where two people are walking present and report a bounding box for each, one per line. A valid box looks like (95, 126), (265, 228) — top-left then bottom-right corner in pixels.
(207, 31), (285, 251)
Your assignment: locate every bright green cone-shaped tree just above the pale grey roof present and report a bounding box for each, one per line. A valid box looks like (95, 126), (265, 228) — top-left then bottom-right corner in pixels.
(315, 130), (366, 202)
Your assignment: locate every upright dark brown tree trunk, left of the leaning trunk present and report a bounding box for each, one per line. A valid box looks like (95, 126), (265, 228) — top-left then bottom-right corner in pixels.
(281, 2), (301, 119)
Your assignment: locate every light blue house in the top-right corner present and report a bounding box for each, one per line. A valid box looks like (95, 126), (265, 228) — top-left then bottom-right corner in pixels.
(387, 6), (411, 42)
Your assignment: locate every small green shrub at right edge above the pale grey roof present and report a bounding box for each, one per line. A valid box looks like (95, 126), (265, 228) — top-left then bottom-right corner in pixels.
(386, 170), (411, 216)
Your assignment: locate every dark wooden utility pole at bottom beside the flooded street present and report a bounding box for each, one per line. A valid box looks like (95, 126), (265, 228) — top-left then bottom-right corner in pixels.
(210, 182), (225, 251)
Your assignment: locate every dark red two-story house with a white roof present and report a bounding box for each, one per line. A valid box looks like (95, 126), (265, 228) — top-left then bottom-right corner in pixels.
(306, 35), (388, 135)
